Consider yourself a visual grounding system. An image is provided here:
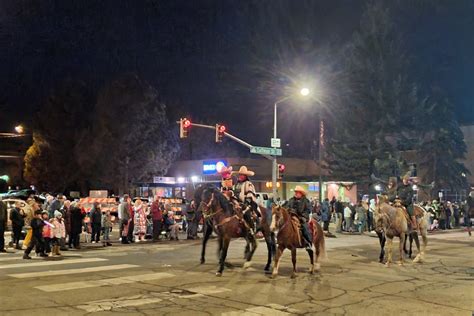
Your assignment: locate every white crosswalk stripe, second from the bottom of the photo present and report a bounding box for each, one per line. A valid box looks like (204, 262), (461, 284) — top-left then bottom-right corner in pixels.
(35, 272), (174, 292)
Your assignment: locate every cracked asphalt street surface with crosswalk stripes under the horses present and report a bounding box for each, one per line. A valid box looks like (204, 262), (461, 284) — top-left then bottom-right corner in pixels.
(0, 231), (474, 316)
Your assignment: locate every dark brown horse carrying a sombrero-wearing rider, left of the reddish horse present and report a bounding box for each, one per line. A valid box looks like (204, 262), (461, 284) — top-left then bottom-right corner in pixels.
(194, 185), (275, 273)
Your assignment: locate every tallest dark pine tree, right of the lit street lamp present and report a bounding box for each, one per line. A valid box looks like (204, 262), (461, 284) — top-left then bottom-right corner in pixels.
(327, 2), (420, 181)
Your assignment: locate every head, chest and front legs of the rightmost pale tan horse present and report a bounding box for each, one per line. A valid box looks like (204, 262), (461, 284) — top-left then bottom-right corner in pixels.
(374, 196), (408, 266)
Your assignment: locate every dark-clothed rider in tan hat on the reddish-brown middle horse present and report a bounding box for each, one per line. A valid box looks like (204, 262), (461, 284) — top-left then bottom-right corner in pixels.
(287, 185), (312, 250)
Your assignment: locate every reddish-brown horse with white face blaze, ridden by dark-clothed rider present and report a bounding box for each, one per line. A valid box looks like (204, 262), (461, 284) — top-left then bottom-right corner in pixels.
(271, 205), (326, 278)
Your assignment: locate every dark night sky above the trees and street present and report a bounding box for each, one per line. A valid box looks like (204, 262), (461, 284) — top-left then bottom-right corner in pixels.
(0, 0), (474, 138)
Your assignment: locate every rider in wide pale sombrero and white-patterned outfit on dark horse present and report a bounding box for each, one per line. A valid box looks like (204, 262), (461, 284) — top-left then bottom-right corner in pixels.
(234, 166), (261, 232)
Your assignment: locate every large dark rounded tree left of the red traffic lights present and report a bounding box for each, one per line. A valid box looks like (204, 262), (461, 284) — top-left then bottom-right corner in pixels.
(80, 75), (179, 193)
